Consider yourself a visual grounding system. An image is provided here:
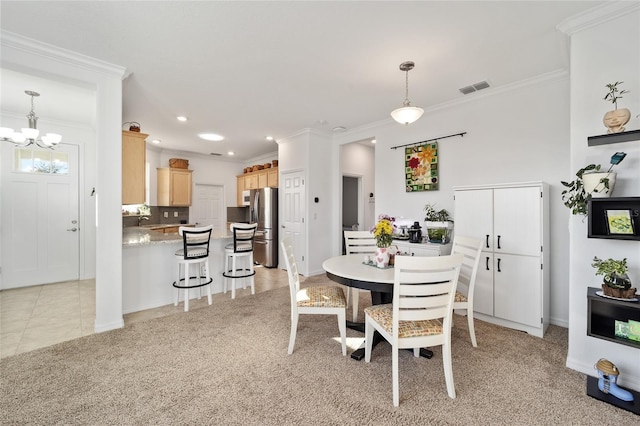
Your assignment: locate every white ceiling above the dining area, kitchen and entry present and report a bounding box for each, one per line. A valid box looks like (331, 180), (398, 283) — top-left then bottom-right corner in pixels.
(0, 1), (604, 160)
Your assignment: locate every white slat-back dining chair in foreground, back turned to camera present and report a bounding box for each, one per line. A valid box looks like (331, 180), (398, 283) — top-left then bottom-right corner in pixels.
(364, 254), (463, 407)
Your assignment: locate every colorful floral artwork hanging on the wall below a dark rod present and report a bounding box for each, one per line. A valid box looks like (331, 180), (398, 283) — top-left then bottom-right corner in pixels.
(404, 142), (439, 192)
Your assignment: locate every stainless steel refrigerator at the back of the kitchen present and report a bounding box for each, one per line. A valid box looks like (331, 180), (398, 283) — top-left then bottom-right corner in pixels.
(249, 188), (278, 268)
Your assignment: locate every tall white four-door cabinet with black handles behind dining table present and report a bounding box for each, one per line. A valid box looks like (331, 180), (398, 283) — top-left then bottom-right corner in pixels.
(454, 182), (549, 337)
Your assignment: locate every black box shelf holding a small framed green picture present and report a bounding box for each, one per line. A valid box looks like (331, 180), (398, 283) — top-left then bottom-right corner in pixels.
(587, 197), (640, 241)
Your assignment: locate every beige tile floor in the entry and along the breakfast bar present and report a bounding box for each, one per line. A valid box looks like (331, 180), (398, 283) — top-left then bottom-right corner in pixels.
(0, 267), (288, 358)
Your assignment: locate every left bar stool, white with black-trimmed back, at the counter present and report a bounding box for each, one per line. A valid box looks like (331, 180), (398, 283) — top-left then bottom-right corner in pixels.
(173, 225), (213, 312)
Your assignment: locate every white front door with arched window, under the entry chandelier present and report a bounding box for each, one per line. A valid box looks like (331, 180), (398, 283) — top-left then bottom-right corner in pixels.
(0, 142), (82, 289)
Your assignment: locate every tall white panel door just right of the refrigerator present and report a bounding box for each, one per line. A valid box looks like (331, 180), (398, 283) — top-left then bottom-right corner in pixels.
(280, 171), (307, 275)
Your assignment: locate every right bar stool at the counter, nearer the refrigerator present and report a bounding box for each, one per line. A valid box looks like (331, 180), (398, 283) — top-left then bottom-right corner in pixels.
(222, 223), (258, 299)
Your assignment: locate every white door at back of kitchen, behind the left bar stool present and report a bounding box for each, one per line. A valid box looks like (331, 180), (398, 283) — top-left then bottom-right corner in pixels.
(189, 183), (226, 235)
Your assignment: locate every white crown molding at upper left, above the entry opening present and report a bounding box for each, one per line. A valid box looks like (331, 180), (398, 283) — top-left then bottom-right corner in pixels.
(0, 30), (127, 79)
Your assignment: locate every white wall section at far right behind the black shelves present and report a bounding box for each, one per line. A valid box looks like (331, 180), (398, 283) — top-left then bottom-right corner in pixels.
(565, 3), (640, 390)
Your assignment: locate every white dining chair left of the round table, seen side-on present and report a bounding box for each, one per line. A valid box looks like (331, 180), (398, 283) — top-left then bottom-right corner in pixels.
(280, 237), (347, 355)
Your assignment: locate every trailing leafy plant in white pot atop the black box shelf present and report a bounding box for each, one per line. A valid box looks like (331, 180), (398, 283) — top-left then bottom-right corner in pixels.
(560, 152), (627, 216)
